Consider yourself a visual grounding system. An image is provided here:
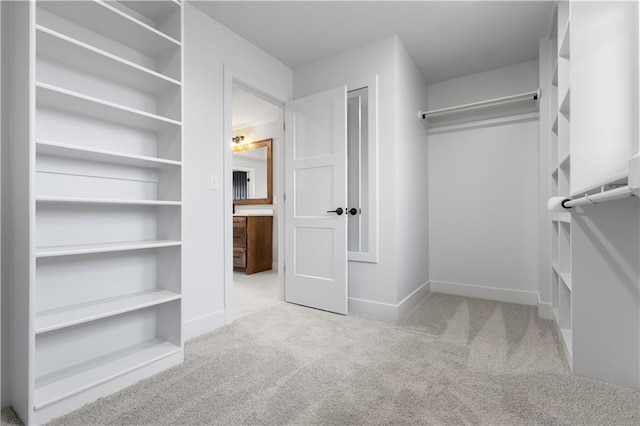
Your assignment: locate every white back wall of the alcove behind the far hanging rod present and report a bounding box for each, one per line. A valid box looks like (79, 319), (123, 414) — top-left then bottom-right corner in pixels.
(428, 61), (539, 304)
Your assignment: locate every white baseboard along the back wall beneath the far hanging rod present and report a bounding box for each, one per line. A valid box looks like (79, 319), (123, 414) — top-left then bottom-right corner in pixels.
(430, 281), (538, 306)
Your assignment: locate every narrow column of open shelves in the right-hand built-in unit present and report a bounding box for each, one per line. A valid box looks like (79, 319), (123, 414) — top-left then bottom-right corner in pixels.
(550, 1), (573, 368)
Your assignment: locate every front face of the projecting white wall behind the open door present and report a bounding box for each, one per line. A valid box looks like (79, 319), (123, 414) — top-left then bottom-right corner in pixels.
(294, 37), (397, 314)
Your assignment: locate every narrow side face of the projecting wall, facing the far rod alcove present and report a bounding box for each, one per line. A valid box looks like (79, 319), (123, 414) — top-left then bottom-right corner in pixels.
(395, 41), (429, 313)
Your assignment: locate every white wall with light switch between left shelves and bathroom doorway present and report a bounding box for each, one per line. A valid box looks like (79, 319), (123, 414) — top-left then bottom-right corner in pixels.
(182, 3), (292, 339)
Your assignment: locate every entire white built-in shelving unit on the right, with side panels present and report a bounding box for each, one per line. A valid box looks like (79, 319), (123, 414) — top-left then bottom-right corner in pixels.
(543, 1), (640, 388)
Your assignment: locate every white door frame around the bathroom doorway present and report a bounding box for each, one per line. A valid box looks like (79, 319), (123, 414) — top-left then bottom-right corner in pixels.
(221, 64), (286, 324)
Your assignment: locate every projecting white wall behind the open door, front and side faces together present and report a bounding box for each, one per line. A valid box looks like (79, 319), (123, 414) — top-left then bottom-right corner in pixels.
(294, 36), (428, 318)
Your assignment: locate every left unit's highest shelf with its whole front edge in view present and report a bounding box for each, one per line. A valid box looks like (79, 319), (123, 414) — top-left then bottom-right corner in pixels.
(36, 25), (182, 95)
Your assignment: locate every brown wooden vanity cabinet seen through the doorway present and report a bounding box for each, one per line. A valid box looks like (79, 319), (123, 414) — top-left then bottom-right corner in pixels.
(233, 216), (273, 274)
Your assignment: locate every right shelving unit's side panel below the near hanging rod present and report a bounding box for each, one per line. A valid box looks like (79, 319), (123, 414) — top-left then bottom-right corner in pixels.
(571, 198), (640, 389)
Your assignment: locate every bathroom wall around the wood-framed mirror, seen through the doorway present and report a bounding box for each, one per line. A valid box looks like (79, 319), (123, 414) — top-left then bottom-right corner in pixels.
(233, 121), (284, 269)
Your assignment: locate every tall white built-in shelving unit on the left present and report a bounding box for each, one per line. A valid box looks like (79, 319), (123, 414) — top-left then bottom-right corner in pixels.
(9, 1), (183, 424)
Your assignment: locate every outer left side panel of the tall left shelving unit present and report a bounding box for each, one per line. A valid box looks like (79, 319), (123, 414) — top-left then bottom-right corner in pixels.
(2, 2), (35, 423)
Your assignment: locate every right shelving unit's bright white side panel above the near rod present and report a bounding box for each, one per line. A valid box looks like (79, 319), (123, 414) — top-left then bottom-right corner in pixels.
(571, 2), (639, 193)
